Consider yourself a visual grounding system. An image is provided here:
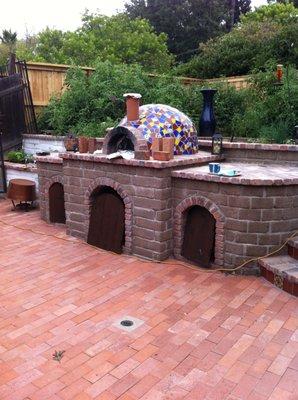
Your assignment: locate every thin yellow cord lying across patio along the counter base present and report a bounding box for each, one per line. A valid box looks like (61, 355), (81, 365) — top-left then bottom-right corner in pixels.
(0, 219), (298, 273)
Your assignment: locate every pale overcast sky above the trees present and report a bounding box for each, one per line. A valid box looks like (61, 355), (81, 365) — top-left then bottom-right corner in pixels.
(0, 0), (267, 37)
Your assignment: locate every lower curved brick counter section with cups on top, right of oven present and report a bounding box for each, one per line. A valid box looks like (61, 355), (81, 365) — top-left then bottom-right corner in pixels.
(172, 164), (298, 267)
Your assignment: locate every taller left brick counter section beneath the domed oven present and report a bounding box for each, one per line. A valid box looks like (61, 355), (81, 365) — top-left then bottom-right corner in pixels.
(37, 152), (218, 260)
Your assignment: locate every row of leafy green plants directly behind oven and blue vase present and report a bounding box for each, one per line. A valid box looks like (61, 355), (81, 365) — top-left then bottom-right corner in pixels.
(39, 62), (298, 142)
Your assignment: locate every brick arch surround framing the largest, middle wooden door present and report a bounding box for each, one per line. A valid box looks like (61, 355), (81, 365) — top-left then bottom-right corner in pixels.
(84, 178), (132, 254)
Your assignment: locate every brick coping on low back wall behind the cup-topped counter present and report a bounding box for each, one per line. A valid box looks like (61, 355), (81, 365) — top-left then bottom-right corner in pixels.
(199, 139), (298, 152)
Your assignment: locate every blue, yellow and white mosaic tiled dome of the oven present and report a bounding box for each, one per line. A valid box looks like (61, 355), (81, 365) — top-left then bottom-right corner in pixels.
(119, 104), (198, 155)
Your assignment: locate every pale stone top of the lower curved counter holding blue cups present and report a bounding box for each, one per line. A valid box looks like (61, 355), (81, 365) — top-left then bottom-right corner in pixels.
(172, 163), (298, 186)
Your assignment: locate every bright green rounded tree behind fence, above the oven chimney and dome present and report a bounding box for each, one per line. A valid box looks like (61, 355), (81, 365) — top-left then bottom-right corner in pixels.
(78, 13), (173, 72)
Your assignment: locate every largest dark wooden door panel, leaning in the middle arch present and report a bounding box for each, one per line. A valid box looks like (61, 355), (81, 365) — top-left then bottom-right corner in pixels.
(88, 191), (125, 254)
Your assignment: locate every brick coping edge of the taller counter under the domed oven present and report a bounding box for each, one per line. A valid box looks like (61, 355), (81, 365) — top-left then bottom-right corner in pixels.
(57, 151), (222, 168)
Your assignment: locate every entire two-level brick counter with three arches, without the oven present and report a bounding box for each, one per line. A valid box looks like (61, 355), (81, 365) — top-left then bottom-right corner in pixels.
(37, 151), (298, 268)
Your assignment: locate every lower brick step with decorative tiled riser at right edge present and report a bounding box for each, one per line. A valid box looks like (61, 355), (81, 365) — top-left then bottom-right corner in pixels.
(259, 255), (298, 296)
